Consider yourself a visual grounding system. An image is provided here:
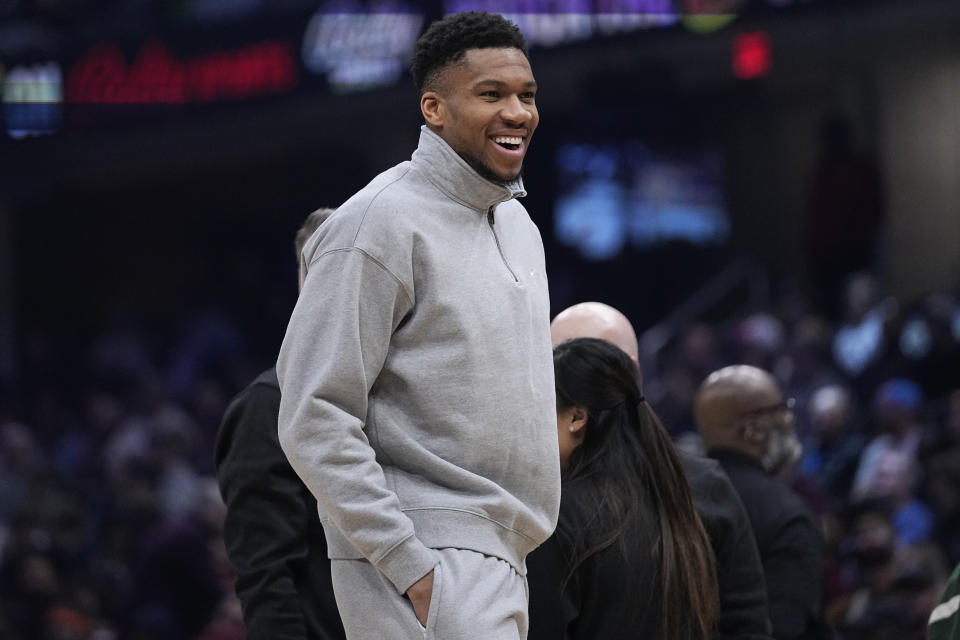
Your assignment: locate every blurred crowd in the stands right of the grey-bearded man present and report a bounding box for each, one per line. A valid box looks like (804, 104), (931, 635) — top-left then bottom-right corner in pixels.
(646, 273), (960, 640)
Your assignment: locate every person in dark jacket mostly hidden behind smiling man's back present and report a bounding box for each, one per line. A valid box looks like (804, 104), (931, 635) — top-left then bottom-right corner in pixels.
(215, 209), (345, 640)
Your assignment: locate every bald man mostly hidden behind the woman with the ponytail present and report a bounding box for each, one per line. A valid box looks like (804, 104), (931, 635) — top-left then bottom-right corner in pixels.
(531, 302), (769, 640)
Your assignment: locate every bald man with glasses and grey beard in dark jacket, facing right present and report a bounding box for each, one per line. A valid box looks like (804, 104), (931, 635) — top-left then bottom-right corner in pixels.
(694, 365), (828, 640)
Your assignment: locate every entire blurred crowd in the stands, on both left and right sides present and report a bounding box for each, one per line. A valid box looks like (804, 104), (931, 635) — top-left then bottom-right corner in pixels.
(0, 273), (960, 640)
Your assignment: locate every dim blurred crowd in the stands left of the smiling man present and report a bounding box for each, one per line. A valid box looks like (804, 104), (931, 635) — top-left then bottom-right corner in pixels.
(0, 313), (259, 640)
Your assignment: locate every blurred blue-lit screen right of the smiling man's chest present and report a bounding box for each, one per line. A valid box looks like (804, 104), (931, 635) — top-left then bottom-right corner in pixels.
(554, 142), (730, 261)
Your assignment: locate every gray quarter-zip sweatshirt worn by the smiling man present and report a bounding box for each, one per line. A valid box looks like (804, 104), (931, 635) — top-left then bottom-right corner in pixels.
(277, 127), (560, 593)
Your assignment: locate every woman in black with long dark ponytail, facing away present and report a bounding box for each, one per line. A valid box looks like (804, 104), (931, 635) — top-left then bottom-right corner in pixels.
(527, 338), (718, 640)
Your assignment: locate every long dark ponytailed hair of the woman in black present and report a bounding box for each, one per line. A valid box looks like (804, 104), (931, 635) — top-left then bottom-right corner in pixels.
(554, 338), (719, 640)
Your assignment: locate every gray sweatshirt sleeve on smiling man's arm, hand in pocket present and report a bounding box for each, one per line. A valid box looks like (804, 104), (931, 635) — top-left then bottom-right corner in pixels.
(277, 247), (436, 594)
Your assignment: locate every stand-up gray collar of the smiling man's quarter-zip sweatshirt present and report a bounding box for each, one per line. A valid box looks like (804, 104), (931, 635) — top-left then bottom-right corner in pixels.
(411, 125), (527, 213)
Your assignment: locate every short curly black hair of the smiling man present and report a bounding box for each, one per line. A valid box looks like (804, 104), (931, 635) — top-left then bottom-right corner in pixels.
(410, 11), (527, 94)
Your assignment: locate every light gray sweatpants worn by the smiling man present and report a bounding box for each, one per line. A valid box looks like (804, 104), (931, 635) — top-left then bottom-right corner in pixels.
(330, 549), (529, 640)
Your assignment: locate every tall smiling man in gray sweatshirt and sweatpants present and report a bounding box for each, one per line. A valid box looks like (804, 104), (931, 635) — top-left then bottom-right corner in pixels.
(277, 13), (560, 640)
